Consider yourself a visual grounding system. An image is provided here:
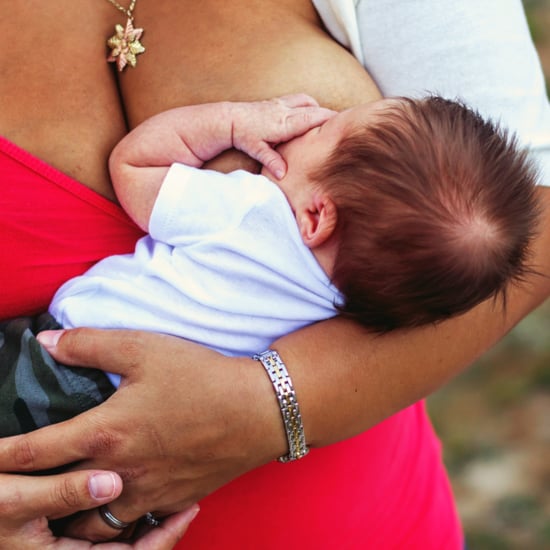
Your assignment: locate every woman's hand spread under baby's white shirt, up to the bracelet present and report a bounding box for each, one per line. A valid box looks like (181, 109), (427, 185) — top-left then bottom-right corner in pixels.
(0, 329), (286, 540)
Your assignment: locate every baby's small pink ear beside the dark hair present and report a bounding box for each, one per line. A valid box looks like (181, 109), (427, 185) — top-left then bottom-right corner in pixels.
(296, 191), (338, 249)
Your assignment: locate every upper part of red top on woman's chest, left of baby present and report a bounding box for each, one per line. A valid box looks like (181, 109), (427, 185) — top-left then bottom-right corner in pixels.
(0, 136), (142, 319)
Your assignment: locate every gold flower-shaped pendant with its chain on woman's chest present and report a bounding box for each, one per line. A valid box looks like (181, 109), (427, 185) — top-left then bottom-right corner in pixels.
(107, 0), (145, 72)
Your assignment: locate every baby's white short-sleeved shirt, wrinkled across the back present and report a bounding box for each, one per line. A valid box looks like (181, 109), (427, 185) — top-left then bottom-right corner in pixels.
(50, 165), (339, 385)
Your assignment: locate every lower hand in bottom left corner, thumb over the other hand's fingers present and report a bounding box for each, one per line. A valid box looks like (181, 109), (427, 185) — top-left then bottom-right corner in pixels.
(0, 471), (194, 550)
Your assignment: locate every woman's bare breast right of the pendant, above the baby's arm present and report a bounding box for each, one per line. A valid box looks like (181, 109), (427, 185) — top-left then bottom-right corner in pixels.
(122, 0), (379, 125)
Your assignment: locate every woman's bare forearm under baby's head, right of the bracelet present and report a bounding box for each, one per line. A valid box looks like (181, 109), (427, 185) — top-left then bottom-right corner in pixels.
(273, 188), (550, 446)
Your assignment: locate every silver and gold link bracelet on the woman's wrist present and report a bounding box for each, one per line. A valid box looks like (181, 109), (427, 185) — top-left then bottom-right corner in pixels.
(253, 350), (309, 462)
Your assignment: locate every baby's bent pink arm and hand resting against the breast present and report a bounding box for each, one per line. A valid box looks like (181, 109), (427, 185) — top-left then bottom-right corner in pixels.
(109, 94), (334, 231)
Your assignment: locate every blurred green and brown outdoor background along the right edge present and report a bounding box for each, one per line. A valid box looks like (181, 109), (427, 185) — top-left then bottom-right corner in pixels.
(428, 0), (550, 550)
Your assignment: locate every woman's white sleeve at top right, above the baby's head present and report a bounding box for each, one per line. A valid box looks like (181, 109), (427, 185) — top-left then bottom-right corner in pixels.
(313, 0), (550, 186)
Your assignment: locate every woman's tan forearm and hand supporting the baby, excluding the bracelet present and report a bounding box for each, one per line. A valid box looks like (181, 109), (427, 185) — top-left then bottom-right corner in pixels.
(0, 185), (550, 536)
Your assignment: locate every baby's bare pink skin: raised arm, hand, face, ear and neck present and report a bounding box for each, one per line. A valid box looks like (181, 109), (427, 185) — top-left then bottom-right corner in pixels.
(109, 94), (356, 276)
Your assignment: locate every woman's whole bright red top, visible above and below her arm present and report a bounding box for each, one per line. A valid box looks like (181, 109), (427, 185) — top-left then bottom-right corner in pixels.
(0, 137), (462, 550)
